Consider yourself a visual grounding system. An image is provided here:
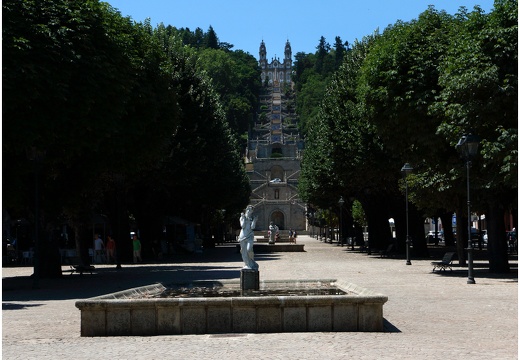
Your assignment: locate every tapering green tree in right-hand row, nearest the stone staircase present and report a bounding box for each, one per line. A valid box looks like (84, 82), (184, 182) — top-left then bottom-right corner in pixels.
(301, 33), (397, 253)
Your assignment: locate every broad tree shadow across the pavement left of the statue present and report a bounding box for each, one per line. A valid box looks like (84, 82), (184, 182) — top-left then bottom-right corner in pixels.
(2, 246), (256, 302)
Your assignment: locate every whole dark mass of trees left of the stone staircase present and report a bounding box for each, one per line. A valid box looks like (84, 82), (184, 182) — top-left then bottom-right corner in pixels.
(2, 0), (260, 276)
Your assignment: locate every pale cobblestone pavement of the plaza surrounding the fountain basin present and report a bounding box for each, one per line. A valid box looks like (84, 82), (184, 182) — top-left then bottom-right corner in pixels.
(2, 236), (518, 360)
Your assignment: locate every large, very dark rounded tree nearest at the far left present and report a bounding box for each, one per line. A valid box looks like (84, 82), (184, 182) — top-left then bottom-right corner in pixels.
(3, 1), (181, 275)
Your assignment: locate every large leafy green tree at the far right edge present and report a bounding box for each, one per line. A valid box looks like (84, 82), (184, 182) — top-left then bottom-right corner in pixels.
(432, 0), (518, 272)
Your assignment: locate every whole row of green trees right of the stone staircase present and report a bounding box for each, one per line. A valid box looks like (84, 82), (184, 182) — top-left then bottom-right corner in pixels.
(296, 0), (518, 272)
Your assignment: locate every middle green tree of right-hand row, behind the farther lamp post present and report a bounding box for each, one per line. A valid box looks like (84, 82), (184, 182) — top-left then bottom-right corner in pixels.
(359, 6), (456, 259)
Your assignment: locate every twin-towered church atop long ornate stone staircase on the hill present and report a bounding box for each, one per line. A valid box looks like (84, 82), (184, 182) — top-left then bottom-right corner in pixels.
(246, 41), (306, 231)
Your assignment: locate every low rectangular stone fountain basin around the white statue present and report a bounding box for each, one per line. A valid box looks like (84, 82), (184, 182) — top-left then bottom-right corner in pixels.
(76, 279), (388, 336)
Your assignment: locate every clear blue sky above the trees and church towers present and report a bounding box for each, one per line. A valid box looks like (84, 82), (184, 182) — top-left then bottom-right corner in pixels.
(105, 0), (493, 59)
